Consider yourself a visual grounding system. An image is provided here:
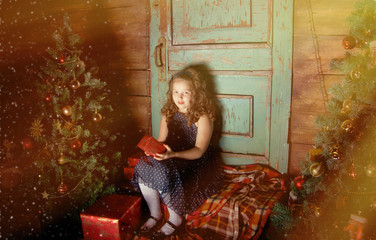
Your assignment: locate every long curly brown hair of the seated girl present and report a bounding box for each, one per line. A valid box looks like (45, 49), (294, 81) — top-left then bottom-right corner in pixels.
(161, 67), (216, 126)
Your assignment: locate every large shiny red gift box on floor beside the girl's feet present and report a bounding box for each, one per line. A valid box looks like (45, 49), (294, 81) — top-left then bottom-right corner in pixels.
(80, 194), (141, 240)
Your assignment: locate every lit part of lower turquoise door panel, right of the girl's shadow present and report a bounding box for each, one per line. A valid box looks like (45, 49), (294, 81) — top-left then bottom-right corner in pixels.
(214, 74), (270, 159)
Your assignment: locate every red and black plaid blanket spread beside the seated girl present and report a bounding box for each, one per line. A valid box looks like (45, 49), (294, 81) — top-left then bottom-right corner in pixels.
(184, 164), (286, 239)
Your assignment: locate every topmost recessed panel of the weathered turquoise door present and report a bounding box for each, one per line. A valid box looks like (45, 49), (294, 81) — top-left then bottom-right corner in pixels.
(171, 0), (270, 45)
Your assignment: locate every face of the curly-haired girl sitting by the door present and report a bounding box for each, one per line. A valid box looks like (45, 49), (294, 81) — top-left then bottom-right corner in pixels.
(172, 78), (192, 113)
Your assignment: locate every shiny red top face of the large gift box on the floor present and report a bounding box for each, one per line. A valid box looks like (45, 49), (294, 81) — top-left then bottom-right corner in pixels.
(81, 194), (141, 219)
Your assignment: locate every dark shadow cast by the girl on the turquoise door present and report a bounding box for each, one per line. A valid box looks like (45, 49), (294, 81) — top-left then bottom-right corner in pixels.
(181, 62), (223, 164)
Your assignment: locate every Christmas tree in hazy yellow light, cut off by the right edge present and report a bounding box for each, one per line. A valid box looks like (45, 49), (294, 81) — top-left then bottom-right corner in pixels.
(272, 0), (376, 239)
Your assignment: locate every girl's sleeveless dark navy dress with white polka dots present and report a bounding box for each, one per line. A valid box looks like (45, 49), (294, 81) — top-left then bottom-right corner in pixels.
(131, 113), (223, 216)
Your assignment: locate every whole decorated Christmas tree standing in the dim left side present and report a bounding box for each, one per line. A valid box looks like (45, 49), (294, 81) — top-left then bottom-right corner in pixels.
(22, 16), (121, 219)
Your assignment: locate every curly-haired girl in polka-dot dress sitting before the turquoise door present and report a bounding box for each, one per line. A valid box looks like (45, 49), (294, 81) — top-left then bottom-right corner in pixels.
(132, 67), (222, 239)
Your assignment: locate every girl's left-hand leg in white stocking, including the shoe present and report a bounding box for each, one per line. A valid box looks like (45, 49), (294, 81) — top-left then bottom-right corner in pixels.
(139, 183), (162, 228)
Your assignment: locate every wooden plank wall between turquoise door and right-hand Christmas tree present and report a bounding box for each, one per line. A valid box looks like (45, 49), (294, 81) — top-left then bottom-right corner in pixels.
(289, 0), (356, 175)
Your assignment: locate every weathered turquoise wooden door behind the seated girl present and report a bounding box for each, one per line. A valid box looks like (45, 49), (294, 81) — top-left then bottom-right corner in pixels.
(150, 0), (293, 172)
